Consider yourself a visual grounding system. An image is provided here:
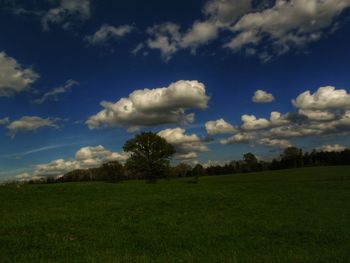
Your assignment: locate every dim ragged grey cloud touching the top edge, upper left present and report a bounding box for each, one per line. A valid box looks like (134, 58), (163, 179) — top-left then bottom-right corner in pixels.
(41, 0), (90, 31)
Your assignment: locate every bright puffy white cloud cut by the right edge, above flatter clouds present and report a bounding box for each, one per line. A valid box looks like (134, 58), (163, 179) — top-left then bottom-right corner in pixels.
(292, 86), (350, 110)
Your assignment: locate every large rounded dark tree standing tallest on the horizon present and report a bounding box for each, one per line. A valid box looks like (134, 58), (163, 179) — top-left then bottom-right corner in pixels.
(123, 132), (175, 182)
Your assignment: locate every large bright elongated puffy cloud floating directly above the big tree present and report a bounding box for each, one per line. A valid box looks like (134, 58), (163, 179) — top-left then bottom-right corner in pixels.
(86, 80), (209, 130)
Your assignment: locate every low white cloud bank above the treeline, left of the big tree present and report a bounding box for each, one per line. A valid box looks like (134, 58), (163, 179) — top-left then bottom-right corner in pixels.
(17, 145), (128, 180)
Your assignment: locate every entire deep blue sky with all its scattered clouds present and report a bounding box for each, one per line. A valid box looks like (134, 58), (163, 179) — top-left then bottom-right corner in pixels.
(0, 0), (350, 181)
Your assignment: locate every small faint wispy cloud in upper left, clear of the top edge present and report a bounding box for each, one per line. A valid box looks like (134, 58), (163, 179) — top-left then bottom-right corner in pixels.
(86, 24), (135, 45)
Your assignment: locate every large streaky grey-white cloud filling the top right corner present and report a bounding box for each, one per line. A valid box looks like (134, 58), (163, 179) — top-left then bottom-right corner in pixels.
(225, 0), (350, 58)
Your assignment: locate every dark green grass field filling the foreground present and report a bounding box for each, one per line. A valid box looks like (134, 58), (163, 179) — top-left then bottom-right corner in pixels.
(0, 166), (350, 263)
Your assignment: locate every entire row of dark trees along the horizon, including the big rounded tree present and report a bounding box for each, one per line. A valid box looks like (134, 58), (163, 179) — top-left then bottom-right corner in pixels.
(29, 144), (350, 186)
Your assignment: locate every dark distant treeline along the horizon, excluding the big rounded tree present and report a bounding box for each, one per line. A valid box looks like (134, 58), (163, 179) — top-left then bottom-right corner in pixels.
(39, 147), (350, 186)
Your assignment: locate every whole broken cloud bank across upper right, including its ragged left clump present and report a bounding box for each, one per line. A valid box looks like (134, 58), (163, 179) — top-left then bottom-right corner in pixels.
(142, 0), (350, 62)
